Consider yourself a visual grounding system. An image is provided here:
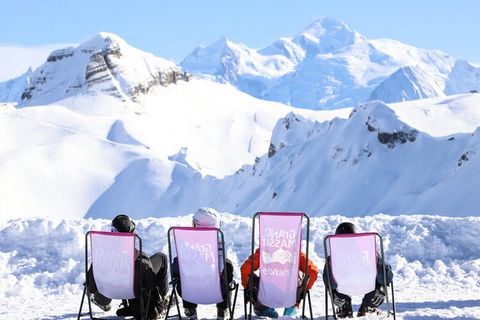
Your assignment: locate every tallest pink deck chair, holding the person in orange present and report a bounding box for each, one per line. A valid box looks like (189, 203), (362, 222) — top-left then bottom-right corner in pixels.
(244, 212), (313, 319)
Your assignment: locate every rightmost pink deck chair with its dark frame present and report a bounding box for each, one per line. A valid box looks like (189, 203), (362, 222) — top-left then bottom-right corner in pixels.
(324, 232), (395, 319)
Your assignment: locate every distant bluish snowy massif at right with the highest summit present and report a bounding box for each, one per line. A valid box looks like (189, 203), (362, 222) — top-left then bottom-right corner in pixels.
(181, 18), (480, 109)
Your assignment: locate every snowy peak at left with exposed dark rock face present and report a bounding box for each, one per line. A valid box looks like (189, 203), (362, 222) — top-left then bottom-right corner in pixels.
(4, 32), (189, 105)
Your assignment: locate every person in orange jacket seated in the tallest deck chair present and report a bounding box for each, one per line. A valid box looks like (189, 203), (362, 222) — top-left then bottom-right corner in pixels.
(240, 249), (318, 318)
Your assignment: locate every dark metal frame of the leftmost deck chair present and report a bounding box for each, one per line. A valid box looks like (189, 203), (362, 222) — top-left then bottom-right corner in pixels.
(77, 231), (150, 320)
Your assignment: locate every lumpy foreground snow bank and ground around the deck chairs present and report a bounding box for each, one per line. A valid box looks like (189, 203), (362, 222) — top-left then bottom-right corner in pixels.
(0, 214), (480, 320)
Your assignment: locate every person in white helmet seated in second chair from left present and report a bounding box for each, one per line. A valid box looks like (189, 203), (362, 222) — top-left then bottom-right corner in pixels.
(171, 208), (233, 320)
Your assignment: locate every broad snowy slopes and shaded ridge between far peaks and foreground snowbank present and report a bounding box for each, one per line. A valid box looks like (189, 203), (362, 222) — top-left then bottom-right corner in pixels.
(0, 85), (480, 219)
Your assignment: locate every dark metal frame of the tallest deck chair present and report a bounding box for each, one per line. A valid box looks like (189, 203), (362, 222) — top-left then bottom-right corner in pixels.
(244, 212), (313, 320)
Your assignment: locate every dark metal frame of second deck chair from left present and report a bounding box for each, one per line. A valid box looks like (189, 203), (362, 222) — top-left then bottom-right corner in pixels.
(165, 227), (238, 320)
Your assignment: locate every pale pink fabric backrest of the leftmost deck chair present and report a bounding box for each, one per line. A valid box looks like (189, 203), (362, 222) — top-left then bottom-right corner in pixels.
(87, 231), (138, 299)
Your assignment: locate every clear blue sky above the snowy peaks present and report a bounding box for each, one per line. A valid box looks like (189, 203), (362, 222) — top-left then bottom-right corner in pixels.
(0, 0), (480, 63)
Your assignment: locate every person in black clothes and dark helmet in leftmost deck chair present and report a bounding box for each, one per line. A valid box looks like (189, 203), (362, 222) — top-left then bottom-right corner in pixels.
(87, 214), (168, 319)
